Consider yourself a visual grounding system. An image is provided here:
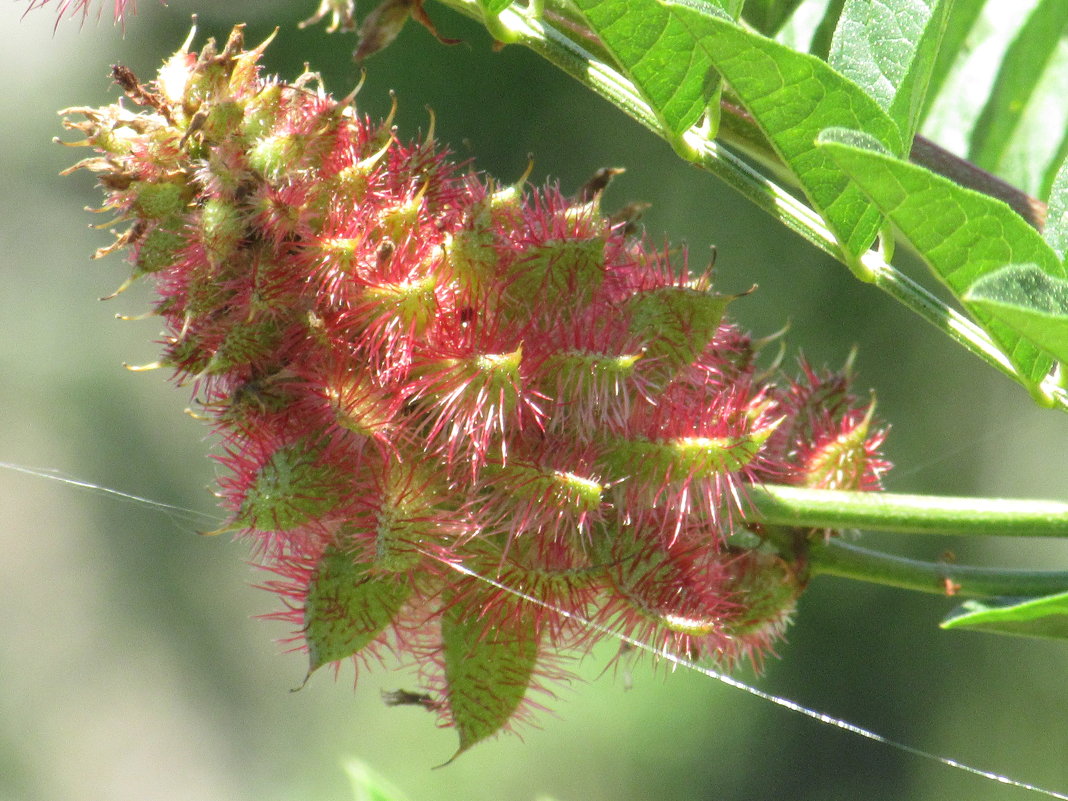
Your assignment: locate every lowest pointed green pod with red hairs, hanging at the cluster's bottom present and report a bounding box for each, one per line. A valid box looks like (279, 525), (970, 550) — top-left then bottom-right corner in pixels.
(441, 598), (538, 759)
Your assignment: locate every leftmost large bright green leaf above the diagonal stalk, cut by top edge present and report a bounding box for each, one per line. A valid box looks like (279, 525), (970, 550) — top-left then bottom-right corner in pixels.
(575, 0), (740, 139)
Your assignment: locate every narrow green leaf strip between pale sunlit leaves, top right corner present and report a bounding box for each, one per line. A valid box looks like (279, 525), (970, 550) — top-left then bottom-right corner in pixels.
(968, 0), (1068, 172)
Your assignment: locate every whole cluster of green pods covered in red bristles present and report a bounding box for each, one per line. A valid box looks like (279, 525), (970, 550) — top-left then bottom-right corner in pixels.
(60, 21), (888, 751)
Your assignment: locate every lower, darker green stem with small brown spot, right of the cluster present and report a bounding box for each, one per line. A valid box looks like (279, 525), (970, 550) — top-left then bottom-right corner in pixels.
(810, 539), (1068, 597)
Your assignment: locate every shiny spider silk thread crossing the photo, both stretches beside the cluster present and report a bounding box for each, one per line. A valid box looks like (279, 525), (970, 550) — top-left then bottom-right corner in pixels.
(0, 461), (1068, 801)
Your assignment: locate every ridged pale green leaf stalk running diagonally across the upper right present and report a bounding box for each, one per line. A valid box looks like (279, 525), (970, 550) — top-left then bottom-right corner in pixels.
(425, 0), (1068, 409)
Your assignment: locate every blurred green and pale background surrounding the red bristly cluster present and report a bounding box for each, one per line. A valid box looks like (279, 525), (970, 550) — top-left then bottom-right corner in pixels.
(0, 0), (1068, 801)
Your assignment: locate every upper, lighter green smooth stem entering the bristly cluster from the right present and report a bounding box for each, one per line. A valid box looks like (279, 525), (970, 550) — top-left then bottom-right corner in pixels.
(745, 484), (1068, 537)
